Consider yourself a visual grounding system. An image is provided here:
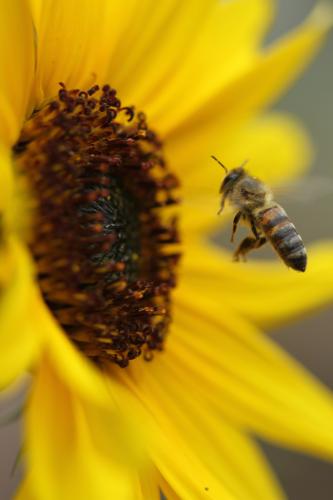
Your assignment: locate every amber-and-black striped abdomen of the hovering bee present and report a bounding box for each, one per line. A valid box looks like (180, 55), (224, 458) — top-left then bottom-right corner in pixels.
(256, 205), (306, 272)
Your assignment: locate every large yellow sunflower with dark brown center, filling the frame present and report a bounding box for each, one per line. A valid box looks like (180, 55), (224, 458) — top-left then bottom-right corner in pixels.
(0, 0), (333, 500)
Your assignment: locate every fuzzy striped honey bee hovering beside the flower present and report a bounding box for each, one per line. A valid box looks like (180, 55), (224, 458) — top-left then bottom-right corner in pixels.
(212, 156), (307, 272)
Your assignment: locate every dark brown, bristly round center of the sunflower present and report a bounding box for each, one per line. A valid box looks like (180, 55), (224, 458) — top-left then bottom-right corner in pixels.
(14, 84), (179, 367)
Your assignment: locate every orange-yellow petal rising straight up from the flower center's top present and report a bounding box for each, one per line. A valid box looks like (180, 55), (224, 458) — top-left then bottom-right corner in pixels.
(30, 0), (138, 103)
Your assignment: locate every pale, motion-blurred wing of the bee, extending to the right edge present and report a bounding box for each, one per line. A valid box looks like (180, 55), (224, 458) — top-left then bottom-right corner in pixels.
(273, 175), (333, 203)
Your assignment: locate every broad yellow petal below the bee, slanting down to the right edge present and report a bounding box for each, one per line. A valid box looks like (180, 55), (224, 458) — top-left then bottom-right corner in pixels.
(167, 298), (333, 459)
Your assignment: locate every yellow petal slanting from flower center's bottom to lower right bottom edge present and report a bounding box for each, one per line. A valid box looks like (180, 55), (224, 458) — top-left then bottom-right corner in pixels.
(120, 356), (284, 500)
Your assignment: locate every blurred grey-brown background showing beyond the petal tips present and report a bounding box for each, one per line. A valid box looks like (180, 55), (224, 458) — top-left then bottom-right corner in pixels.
(0, 0), (333, 500)
